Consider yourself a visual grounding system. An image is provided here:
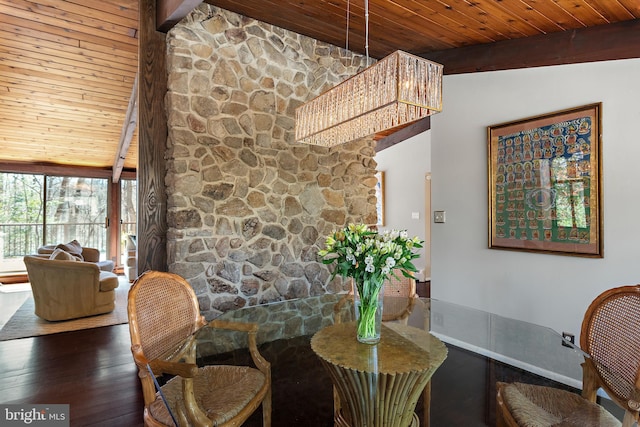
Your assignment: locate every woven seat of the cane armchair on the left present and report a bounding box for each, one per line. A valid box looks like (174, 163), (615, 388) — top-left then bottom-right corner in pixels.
(149, 365), (267, 426)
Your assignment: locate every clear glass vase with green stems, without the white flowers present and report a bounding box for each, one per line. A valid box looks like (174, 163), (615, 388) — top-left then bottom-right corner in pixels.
(354, 281), (384, 344)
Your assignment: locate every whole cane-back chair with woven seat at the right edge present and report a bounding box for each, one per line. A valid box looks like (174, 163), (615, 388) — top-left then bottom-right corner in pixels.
(497, 285), (640, 427)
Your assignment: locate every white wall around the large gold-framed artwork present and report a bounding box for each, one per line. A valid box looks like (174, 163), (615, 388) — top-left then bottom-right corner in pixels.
(430, 59), (640, 337)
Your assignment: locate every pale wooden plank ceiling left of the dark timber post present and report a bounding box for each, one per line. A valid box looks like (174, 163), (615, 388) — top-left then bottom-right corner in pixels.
(0, 0), (138, 172)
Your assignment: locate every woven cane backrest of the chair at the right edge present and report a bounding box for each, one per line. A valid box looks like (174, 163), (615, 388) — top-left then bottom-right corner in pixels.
(580, 285), (640, 401)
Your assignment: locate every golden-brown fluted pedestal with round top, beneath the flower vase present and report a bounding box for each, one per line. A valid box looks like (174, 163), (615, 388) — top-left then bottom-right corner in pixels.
(311, 322), (447, 427)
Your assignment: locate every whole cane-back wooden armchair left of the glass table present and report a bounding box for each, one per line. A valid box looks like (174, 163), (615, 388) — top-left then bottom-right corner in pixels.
(128, 271), (271, 427)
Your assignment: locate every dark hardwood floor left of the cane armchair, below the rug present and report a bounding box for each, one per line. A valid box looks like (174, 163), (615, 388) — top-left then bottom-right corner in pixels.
(0, 324), (143, 427)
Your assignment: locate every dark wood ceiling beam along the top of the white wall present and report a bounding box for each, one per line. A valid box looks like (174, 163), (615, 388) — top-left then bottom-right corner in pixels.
(421, 19), (640, 74)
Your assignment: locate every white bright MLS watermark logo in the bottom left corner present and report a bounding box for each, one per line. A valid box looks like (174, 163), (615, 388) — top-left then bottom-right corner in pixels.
(0, 404), (69, 427)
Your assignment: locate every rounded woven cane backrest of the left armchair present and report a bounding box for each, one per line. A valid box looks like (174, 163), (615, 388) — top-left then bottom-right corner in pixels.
(128, 271), (202, 360)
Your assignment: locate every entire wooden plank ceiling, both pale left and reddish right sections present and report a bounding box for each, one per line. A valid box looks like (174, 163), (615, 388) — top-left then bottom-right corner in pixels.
(0, 0), (640, 172)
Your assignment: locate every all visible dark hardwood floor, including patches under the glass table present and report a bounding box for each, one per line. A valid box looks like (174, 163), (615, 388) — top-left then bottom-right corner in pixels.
(0, 312), (621, 427)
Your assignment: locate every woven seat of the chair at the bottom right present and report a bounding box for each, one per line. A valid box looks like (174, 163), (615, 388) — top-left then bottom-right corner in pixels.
(499, 383), (622, 427)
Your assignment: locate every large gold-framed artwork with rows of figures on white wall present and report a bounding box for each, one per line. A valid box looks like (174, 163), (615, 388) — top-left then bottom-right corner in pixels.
(487, 103), (604, 258)
